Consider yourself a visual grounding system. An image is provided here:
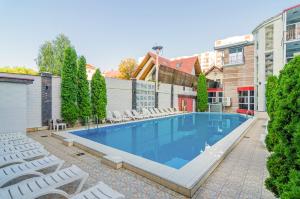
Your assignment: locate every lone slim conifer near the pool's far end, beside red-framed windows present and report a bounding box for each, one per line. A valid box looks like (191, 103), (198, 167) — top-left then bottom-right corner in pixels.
(197, 74), (208, 112)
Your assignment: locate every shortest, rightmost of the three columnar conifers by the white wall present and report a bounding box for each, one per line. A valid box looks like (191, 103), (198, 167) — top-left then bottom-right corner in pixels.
(91, 69), (107, 120)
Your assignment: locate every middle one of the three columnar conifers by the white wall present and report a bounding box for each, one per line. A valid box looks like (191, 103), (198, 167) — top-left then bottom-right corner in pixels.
(77, 56), (91, 124)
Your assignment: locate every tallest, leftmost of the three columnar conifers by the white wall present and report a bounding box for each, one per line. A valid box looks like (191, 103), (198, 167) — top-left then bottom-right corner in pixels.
(61, 47), (78, 125)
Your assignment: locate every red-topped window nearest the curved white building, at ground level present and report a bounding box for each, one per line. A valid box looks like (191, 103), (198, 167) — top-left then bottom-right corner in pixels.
(238, 87), (254, 110)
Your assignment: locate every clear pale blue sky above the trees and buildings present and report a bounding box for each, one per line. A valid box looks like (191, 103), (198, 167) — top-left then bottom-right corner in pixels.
(0, 0), (300, 70)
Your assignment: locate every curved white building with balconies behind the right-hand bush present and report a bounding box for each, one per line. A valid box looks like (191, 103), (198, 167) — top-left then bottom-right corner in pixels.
(252, 4), (300, 111)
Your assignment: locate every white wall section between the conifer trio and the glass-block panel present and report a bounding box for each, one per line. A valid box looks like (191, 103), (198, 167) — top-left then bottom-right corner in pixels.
(105, 78), (132, 112)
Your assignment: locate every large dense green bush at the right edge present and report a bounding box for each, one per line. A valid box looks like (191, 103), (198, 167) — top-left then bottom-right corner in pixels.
(265, 56), (300, 199)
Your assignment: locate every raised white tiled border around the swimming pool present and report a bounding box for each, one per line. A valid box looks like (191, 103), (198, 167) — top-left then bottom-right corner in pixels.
(52, 112), (256, 197)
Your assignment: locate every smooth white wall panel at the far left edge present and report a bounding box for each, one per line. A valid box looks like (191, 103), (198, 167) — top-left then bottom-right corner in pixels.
(0, 82), (27, 133)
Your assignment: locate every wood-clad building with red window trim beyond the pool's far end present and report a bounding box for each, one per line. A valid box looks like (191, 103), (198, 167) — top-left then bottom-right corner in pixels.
(212, 35), (254, 114)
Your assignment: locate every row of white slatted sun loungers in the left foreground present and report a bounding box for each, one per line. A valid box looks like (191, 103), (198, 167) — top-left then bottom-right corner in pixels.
(0, 133), (124, 199)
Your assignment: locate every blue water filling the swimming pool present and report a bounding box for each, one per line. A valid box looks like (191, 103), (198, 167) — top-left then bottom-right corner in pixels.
(72, 113), (246, 169)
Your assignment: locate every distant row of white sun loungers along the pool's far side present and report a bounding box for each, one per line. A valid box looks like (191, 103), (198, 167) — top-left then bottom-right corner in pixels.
(106, 108), (182, 123)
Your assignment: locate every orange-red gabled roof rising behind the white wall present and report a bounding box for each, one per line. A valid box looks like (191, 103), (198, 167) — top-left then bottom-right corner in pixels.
(133, 52), (201, 77)
